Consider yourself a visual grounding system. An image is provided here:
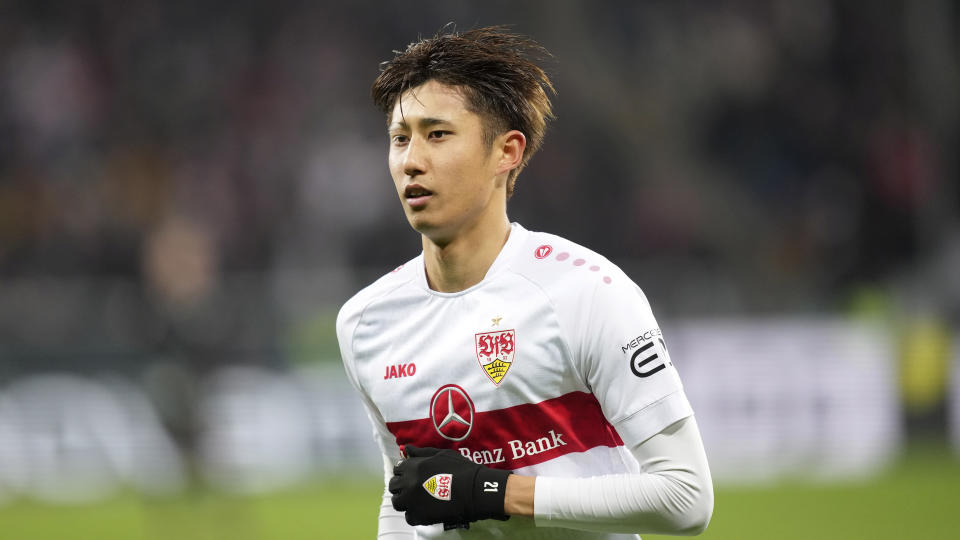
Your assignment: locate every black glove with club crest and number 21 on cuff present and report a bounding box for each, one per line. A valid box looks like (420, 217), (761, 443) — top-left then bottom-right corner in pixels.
(387, 444), (510, 529)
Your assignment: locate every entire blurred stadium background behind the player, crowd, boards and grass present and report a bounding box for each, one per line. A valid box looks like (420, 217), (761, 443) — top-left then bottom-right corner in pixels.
(0, 0), (960, 539)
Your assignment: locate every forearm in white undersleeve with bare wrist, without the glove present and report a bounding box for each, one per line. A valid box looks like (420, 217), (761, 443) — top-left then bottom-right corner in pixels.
(516, 416), (713, 535)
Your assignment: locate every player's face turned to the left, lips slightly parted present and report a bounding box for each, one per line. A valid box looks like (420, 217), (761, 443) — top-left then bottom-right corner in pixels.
(388, 81), (506, 243)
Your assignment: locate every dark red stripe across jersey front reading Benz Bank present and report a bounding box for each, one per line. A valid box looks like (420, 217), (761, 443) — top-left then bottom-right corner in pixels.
(387, 392), (623, 470)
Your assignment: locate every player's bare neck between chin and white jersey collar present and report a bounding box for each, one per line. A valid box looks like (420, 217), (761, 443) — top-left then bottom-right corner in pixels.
(423, 214), (510, 292)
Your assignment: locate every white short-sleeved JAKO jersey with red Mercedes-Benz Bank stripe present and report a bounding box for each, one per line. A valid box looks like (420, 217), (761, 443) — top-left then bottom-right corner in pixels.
(337, 224), (693, 538)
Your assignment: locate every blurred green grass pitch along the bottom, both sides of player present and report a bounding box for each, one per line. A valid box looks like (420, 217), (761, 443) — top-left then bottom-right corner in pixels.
(0, 450), (960, 540)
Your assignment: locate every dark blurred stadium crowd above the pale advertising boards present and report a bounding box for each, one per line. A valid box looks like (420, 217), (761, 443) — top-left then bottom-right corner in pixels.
(0, 0), (960, 376)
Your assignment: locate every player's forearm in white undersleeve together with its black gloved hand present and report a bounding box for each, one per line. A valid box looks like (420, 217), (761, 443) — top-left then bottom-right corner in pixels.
(388, 416), (713, 535)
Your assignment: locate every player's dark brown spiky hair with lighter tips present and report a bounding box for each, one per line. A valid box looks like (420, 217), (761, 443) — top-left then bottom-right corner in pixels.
(370, 25), (556, 197)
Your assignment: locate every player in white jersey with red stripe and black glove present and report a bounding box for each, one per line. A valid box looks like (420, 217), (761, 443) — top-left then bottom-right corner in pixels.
(337, 28), (713, 539)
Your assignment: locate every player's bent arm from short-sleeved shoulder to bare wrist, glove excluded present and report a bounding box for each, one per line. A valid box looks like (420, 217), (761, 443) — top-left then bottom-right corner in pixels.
(507, 271), (713, 534)
